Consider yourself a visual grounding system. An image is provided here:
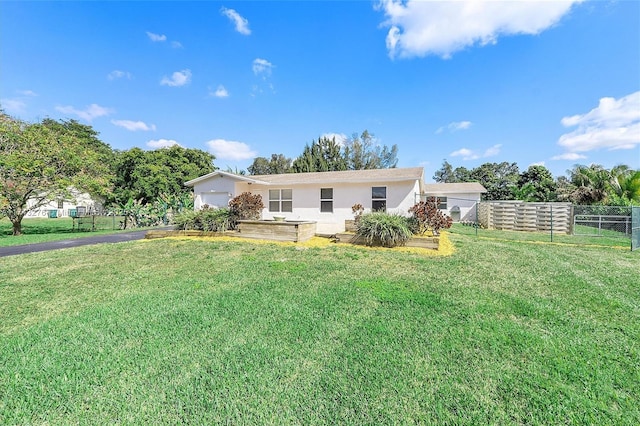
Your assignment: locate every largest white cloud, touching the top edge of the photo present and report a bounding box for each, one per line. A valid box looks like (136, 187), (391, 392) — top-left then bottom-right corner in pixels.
(376, 0), (582, 58)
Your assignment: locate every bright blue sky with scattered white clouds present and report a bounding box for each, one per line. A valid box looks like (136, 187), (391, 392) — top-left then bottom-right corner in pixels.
(0, 0), (640, 182)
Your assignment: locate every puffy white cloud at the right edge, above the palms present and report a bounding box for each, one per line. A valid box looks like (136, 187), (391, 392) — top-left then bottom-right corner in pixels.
(554, 91), (640, 156)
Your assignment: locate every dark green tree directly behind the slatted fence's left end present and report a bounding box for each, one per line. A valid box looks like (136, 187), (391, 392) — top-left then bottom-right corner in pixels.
(470, 161), (520, 200)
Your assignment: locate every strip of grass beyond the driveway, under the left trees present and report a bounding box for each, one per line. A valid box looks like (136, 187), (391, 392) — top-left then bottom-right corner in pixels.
(0, 216), (131, 247)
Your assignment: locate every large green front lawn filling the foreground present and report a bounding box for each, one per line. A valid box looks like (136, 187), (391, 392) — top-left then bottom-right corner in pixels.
(0, 234), (640, 425)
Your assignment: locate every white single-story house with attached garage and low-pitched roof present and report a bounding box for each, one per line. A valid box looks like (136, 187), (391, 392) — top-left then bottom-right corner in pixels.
(185, 167), (485, 234)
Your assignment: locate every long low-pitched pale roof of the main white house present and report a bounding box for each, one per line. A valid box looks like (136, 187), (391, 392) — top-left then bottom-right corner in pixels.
(185, 167), (424, 186)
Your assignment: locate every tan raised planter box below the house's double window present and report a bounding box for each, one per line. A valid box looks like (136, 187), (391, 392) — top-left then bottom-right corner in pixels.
(238, 220), (316, 242)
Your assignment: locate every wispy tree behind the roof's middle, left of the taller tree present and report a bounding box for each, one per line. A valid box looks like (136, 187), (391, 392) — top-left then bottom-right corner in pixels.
(291, 137), (347, 173)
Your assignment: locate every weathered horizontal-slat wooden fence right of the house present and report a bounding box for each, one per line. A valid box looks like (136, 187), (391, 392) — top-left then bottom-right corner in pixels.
(478, 201), (572, 234)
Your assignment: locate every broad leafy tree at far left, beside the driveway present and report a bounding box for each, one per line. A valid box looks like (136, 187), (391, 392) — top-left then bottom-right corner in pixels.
(0, 114), (112, 235)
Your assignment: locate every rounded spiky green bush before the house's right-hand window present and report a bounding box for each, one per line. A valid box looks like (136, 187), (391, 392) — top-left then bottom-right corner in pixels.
(356, 212), (412, 247)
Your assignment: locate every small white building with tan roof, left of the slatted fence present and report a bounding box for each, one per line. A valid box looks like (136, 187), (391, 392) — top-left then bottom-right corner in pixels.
(422, 182), (487, 222)
